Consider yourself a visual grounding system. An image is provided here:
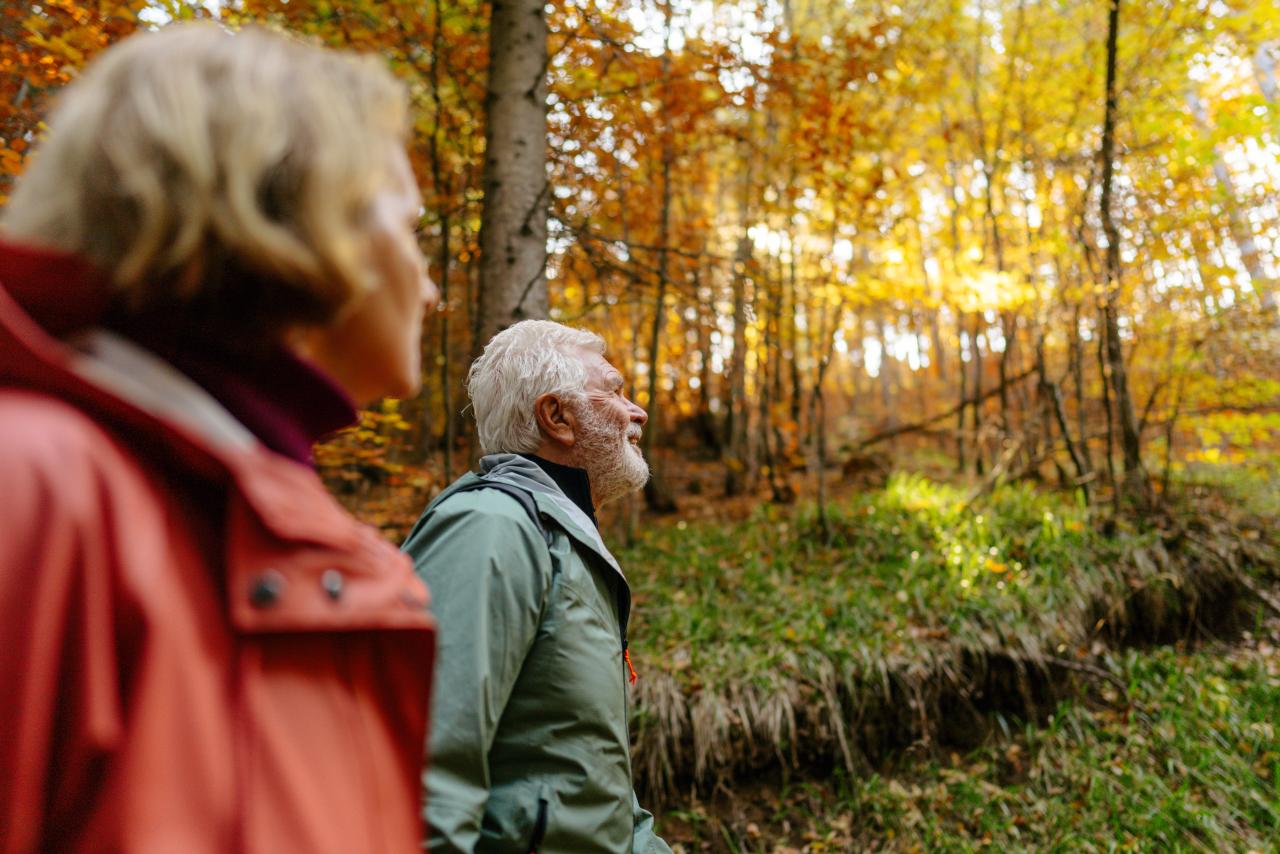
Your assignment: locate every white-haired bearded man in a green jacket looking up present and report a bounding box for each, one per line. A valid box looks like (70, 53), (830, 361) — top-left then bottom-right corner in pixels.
(403, 320), (671, 854)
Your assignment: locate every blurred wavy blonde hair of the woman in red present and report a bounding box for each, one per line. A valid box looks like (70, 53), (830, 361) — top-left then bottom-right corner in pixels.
(0, 23), (407, 334)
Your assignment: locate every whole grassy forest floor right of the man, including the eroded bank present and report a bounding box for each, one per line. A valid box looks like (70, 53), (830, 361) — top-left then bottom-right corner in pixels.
(335, 467), (1280, 853)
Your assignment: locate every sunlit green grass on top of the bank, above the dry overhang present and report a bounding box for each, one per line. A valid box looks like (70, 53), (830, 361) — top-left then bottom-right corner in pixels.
(620, 475), (1144, 688)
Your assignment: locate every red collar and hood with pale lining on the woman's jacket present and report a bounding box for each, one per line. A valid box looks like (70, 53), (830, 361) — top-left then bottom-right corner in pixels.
(0, 241), (360, 548)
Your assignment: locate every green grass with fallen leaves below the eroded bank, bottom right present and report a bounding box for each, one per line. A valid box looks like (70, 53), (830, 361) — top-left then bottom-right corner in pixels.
(672, 645), (1280, 851)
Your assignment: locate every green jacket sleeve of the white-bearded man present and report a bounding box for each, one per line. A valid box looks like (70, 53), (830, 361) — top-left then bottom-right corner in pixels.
(403, 490), (552, 854)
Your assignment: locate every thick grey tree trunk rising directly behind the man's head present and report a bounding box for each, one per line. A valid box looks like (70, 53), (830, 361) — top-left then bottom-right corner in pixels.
(474, 0), (549, 352)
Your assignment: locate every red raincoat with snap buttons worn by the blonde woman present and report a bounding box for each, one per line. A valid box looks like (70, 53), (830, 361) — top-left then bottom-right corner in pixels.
(0, 246), (434, 854)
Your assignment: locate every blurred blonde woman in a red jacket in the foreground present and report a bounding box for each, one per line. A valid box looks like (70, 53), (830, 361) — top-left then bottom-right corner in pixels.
(0, 24), (436, 854)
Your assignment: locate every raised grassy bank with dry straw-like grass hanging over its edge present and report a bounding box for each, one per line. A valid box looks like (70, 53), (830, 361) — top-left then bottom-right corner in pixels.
(620, 475), (1275, 800)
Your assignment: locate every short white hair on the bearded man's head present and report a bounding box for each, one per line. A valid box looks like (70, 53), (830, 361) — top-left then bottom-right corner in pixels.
(467, 320), (604, 453)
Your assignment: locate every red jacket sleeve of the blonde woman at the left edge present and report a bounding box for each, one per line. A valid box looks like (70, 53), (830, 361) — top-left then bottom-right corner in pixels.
(0, 419), (123, 854)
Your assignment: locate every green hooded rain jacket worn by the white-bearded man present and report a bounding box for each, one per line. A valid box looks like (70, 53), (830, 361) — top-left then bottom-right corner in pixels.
(403, 455), (671, 854)
